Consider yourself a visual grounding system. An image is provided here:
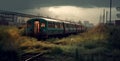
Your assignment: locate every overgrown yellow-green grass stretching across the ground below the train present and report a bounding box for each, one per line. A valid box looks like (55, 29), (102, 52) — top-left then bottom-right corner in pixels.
(0, 25), (120, 61)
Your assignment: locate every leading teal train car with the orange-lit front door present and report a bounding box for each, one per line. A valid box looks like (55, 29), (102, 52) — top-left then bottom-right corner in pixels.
(27, 18), (64, 37)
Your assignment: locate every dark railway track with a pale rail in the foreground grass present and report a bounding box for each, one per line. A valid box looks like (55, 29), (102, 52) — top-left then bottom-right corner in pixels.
(20, 51), (51, 61)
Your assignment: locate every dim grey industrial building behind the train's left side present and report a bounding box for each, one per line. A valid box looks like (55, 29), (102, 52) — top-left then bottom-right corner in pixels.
(0, 10), (38, 27)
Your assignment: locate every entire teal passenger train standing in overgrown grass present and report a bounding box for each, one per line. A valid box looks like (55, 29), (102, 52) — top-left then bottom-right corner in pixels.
(26, 18), (86, 38)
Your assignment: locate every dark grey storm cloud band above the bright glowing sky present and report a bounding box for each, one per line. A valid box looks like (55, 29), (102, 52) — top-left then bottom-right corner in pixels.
(0, 0), (120, 11)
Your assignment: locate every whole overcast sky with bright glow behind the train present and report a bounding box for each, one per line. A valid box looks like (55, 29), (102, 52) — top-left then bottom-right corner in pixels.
(0, 0), (120, 23)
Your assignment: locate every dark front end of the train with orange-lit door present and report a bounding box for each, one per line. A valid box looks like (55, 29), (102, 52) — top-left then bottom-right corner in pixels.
(26, 19), (46, 37)
